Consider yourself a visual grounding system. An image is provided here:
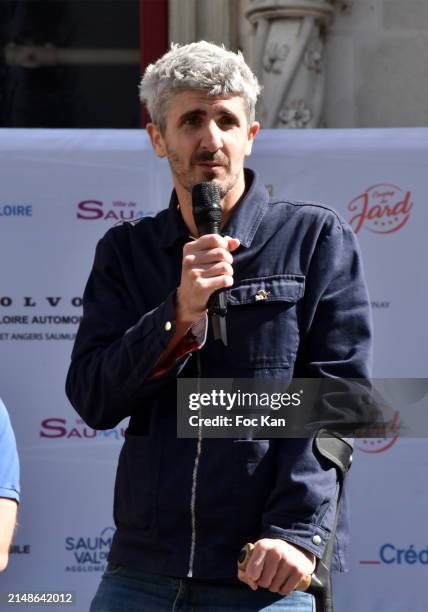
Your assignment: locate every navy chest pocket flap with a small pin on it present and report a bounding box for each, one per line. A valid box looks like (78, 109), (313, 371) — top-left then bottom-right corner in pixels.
(227, 274), (305, 306)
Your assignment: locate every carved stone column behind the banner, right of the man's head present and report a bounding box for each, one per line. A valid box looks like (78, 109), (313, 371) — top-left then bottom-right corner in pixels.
(243, 0), (335, 128)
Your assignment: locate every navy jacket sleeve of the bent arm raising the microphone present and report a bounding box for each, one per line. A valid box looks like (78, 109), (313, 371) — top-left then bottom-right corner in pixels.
(66, 232), (189, 429)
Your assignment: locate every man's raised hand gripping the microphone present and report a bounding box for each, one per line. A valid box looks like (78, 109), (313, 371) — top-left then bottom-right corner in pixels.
(177, 234), (240, 324)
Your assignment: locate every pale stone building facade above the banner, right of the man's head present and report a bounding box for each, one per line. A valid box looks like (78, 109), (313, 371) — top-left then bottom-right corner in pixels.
(169, 0), (428, 128)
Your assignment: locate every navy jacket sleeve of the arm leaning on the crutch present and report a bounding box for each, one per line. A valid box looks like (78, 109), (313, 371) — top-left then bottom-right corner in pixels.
(261, 217), (372, 558)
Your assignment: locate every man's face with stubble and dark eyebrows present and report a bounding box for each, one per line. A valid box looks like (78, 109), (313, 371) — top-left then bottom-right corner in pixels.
(147, 90), (259, 197)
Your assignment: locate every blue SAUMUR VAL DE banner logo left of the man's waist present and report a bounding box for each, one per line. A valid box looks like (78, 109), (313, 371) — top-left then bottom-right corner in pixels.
(65, 527), (115, 572)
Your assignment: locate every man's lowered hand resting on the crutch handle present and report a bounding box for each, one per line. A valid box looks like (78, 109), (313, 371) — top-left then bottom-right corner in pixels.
(238, 538), (315, 596)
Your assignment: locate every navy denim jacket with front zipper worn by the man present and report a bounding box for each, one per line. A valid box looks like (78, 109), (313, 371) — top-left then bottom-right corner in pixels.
(66, 170), (371, 578)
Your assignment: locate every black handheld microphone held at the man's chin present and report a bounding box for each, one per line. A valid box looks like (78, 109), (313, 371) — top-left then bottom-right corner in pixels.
(192, 181), (227, 346)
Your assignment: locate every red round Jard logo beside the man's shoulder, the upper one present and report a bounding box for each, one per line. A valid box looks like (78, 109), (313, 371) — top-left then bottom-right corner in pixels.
(348, 183), (413, 234)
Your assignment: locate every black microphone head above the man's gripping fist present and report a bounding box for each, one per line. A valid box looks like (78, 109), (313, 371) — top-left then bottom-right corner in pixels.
(192, 181), (222, 236)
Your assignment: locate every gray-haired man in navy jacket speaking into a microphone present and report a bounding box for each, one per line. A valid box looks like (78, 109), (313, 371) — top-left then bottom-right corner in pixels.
(67, 41), (371, 612)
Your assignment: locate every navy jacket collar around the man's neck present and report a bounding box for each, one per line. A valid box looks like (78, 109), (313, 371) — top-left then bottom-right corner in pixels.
(161, 168), (269, 248)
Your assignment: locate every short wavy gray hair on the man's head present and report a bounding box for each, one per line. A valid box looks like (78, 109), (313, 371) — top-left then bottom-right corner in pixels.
(140, 40), (260, 130)
